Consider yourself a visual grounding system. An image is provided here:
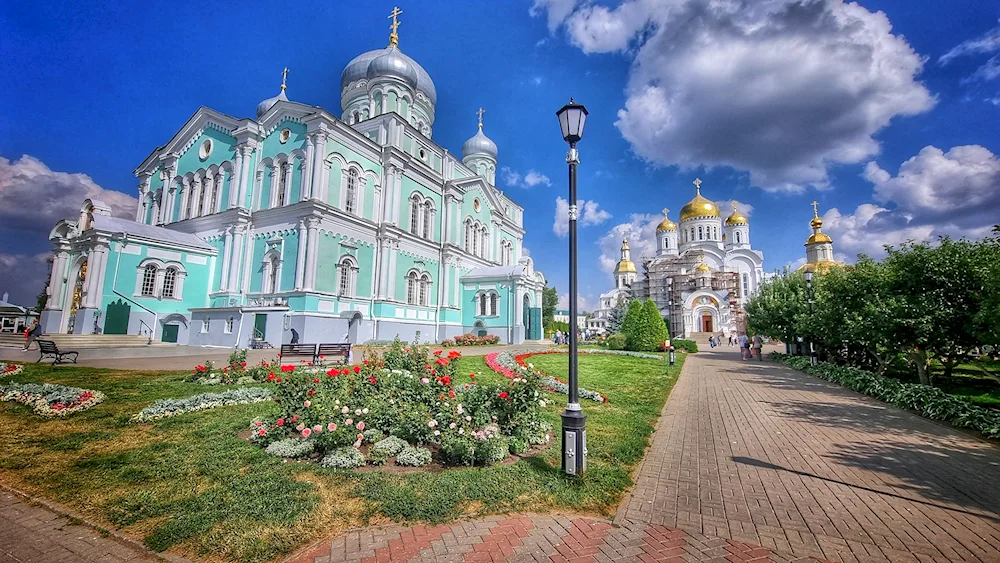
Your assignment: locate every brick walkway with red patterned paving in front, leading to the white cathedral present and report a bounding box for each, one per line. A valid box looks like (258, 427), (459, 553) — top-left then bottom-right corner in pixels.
(289, 348), (1000, 563)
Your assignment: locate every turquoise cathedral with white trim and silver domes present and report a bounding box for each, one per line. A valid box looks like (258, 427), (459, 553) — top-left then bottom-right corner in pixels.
(42, 14), (545, 347)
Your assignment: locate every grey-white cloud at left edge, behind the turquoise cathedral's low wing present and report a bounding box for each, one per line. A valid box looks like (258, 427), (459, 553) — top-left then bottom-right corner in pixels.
(0, 155), (138, 235)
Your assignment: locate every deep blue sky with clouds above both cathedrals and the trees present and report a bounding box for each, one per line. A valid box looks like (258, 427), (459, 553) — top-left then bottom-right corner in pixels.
(0, 0), (1000, 306)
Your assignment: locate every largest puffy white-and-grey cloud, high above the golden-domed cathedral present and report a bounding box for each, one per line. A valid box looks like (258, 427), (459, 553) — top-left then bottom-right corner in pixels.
(532, 0), (935, 191)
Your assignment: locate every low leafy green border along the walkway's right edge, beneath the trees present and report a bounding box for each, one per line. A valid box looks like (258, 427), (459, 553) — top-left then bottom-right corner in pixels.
(771, 352), (1000, 439)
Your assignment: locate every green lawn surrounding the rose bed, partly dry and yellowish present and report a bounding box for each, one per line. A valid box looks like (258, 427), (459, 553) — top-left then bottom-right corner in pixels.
(0, 355), (683, 562)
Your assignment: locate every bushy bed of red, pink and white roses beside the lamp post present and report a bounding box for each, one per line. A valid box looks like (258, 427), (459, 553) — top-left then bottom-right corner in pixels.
(250, 342), (549, 469)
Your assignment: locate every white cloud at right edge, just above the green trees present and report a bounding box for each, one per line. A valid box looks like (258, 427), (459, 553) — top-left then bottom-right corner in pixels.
(823, 145), (1000, 256)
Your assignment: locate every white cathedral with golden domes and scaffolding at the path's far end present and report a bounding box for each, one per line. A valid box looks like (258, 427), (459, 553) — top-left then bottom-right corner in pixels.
(587, 179), (764, 336)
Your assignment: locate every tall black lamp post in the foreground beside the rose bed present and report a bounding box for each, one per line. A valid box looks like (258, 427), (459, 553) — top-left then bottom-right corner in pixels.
(556, 98), (587, 476)
